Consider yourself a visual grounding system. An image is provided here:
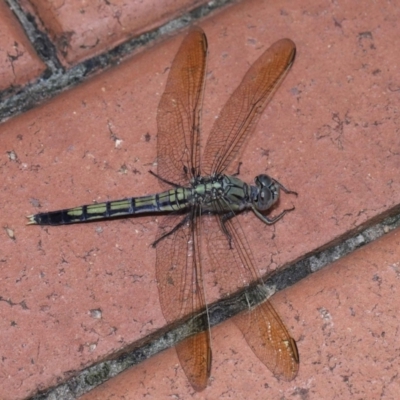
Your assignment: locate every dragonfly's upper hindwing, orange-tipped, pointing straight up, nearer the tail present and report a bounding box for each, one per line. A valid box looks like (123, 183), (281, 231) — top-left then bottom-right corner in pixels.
(157, 27), (207, 186)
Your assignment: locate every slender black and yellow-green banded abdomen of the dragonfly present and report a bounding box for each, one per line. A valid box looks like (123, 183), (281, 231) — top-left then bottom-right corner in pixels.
(28, 188), (190, 225)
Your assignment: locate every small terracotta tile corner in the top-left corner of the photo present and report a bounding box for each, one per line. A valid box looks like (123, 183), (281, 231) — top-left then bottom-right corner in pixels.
(0, 2), (46, 91)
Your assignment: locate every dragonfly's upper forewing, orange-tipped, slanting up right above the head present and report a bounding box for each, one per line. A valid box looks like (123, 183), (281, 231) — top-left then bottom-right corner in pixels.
(202, 39), (296, 175)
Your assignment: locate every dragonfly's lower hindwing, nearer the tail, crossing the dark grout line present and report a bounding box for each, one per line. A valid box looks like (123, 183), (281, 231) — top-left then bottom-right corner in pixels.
(156, 207), (211, 391)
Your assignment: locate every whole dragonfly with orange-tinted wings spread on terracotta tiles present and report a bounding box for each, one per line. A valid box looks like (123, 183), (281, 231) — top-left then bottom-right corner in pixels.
(27, 27), (299, 391)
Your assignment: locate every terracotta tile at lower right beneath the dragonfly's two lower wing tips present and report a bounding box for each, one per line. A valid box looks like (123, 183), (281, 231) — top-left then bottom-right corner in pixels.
(80, 230), (400, 400)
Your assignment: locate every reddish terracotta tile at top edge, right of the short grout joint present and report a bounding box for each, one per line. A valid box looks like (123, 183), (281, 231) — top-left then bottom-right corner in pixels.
(22, 0), (209, 66)
